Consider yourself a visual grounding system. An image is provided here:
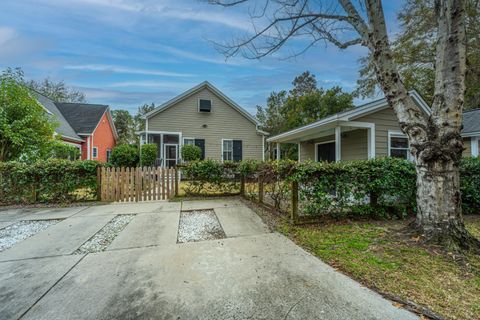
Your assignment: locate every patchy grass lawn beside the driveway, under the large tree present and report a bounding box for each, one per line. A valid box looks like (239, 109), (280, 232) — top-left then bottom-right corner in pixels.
(276, 216), (480, 319)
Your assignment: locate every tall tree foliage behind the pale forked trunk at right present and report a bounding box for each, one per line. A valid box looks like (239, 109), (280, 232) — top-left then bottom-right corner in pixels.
(355, 0), (480, 109)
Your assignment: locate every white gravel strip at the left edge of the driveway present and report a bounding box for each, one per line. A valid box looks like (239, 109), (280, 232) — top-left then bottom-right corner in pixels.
(0, 220), (61, 252)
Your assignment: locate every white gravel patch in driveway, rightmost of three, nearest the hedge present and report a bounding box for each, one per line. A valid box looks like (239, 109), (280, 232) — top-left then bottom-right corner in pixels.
(178, 210), (226, 243)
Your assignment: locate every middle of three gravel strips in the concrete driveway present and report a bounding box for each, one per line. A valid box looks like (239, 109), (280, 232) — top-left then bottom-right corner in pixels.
(73, 214), (135, 254)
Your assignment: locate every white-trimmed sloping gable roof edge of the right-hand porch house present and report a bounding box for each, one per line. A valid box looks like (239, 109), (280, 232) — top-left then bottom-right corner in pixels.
(267, 90), (431, 142)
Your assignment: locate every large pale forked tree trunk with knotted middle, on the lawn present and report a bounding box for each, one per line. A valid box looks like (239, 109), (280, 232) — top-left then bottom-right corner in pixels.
(366, 0), (480, 252)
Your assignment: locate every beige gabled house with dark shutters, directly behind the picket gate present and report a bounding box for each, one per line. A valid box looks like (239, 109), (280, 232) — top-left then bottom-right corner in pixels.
(138, 81), (267, 167)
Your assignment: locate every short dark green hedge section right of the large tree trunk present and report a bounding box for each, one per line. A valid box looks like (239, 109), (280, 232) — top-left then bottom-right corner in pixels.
(460, 157), (480, 214)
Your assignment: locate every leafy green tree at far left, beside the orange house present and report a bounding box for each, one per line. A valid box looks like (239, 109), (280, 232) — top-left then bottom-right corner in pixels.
(0, 69), (56, 161)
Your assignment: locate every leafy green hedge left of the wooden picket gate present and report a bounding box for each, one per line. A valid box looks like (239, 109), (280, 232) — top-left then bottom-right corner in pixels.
(0, 159), (100, 204)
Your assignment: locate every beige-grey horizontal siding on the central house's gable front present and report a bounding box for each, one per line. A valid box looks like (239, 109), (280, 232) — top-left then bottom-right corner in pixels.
(148, 88), (263, 160)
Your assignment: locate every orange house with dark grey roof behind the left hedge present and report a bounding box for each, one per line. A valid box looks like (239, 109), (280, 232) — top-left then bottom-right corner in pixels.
(32, 91), (117, 162)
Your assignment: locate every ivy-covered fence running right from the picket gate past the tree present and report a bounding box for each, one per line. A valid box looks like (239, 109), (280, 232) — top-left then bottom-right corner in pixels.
(181, 158), (480, 220)
